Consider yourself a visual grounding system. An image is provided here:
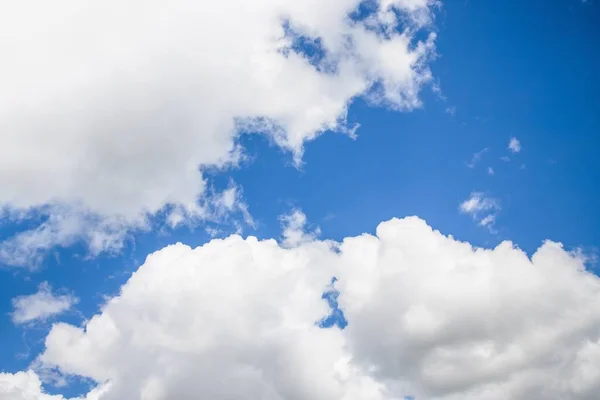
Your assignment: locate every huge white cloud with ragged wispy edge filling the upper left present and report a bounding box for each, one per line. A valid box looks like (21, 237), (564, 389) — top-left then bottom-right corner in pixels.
(0, 0), (437, 268)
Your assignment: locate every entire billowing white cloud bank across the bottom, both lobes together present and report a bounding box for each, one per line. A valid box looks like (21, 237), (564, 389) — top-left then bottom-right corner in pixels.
(0, 217), (600, 400)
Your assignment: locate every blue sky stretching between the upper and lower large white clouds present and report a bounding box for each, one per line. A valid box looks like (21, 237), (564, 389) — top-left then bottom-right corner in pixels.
(0, 0), (600, 398)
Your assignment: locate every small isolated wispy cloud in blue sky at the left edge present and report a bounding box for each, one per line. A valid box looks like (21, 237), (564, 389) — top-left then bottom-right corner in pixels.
(12, 282), (79, 324)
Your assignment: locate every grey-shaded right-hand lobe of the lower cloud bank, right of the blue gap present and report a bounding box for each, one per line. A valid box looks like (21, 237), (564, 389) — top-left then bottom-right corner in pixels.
(339, 220), (600, 400)
